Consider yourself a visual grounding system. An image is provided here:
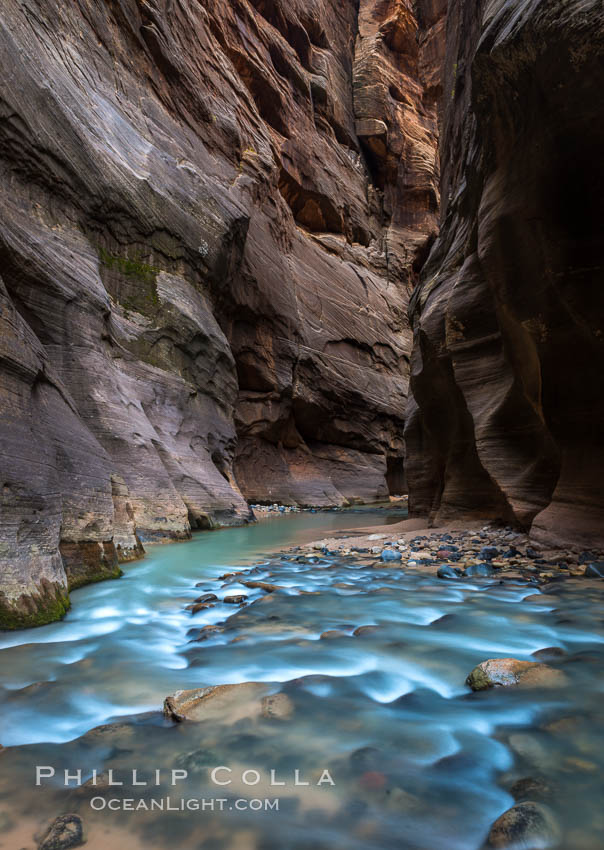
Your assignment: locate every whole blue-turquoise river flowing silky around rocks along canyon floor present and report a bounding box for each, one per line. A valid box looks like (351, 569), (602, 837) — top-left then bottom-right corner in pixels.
(0, 512), (604, 850)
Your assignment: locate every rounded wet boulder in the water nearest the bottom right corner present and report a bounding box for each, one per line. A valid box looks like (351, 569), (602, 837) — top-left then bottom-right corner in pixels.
(486, 800), (560, 850)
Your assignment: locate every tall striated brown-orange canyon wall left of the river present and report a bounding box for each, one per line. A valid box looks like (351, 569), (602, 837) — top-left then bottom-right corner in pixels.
(0, 0), (444, 627)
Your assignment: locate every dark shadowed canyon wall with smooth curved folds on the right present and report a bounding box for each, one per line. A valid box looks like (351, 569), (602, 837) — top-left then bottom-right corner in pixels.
(406, 0), (604, 545)
